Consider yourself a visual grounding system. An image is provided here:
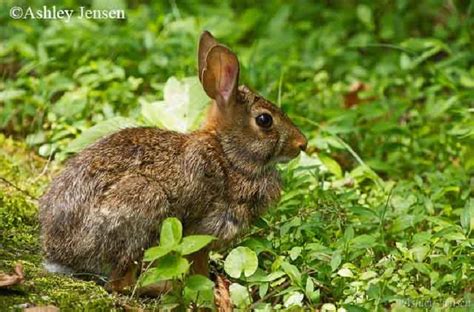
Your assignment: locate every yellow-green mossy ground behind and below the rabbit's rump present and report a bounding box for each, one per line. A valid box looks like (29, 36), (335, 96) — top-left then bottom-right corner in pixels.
(0, 135), (160, 311)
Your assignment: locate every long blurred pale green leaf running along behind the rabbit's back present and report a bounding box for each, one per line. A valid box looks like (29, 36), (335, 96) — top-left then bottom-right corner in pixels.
(66, 117), (139, 153)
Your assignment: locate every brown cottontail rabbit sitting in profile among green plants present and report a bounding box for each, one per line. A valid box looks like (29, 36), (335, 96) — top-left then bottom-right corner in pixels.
(39, 31), (307, 290)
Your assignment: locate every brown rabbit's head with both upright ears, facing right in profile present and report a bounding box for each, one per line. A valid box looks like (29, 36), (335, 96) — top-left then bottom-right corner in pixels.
(198, 31), (307, 171)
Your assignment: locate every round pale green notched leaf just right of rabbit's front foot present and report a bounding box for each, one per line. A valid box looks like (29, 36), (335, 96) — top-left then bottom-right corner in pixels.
(224, 246), (258, 278)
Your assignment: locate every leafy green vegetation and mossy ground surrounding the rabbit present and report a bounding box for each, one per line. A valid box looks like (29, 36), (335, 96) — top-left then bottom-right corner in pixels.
(0, 0), (474, 311)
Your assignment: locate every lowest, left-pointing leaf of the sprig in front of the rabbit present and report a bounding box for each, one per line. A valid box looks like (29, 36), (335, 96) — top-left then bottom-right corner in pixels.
(141, 254), (189, 286)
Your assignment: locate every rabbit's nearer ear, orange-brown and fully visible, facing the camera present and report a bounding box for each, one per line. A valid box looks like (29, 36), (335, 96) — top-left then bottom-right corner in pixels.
(202, 44), (239, 106)
